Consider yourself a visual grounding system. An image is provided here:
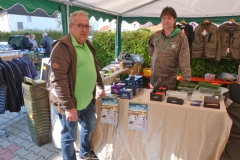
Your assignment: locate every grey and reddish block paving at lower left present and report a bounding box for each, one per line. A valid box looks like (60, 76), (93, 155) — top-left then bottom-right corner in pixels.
(0, 107), (62, 160)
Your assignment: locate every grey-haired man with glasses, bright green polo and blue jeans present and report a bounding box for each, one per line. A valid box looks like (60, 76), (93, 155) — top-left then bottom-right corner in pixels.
(50, 11), (105, 160)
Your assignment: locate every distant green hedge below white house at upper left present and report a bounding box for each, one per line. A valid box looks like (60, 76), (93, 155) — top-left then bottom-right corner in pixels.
(0, 30), (63, 45)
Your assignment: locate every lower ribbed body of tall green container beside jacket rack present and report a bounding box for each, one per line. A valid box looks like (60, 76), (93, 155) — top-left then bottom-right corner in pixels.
(24, 98), (52, 146)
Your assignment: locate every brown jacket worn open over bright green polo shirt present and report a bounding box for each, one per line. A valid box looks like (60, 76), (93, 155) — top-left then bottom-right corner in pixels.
(50, 34), (104, 114)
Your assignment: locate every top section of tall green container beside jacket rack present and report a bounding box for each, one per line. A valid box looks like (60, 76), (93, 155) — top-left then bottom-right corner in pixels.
(22, 77), (47, 101)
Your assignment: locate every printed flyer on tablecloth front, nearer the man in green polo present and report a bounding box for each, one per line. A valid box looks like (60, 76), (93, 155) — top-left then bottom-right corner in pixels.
(101, 98), (118, 125)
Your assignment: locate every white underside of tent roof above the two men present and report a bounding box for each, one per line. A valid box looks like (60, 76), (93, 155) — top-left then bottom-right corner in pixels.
(52, 0), (240, 17)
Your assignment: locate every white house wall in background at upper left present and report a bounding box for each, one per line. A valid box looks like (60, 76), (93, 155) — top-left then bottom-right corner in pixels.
(8, 14), (58, 31)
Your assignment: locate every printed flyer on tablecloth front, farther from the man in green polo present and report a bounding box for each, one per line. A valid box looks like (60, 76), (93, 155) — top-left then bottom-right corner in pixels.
(128, 103), (148, 132)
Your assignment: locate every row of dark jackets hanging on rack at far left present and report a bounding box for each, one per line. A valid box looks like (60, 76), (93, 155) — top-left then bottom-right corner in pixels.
(0, 57), (37, 114)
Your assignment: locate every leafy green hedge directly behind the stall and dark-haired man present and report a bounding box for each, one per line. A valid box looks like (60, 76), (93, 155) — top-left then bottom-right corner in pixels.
(93, 29), (238, 77)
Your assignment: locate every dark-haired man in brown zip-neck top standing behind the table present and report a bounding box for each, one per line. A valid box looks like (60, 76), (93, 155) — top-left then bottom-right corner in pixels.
(148, 7), (191, 90)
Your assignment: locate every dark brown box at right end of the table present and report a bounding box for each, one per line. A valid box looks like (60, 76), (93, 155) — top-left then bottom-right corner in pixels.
(203, 96), (220, 109)
